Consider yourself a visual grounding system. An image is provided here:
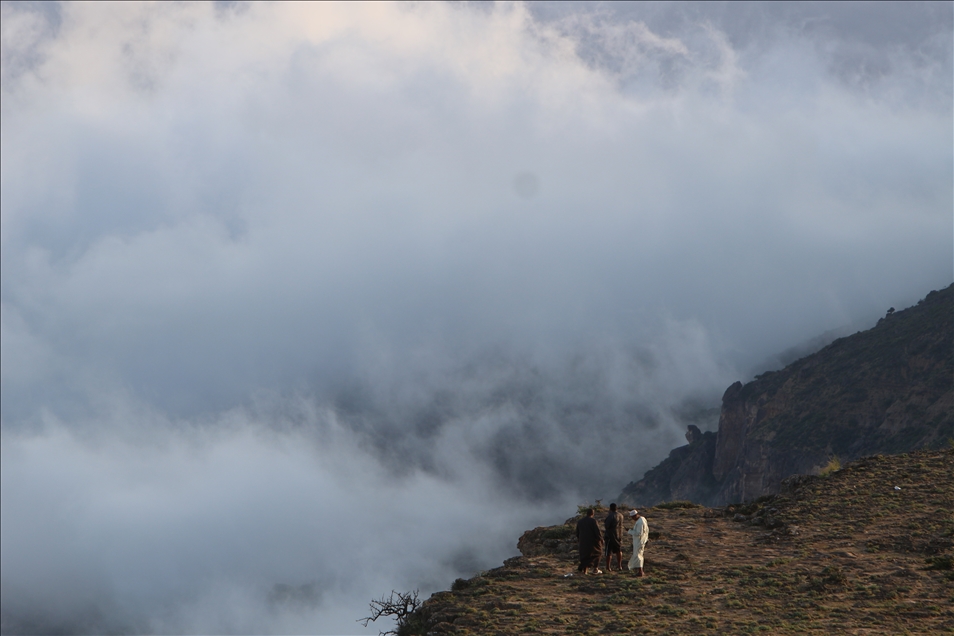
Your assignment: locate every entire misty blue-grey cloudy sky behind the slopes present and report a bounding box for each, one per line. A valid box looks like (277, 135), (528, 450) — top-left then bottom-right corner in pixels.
(0, 2), (954, 634)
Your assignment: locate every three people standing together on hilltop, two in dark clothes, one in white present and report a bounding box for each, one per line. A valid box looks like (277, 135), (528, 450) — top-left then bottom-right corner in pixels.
(576, 504), (649, 576)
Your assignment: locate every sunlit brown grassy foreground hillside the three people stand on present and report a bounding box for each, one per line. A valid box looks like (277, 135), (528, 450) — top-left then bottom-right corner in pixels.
(399, 449), (954, 635)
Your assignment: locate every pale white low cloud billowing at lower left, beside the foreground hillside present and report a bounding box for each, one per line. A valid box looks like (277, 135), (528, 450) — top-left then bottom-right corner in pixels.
(0, 411), (556, 633)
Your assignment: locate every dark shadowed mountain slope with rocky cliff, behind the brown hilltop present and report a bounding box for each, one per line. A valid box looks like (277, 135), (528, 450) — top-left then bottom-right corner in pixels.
(619, 285), (954, 506)
